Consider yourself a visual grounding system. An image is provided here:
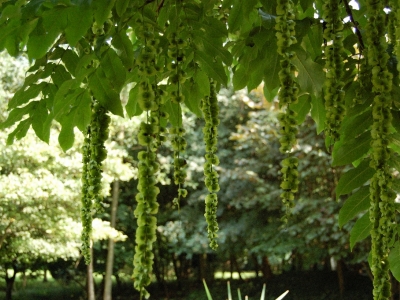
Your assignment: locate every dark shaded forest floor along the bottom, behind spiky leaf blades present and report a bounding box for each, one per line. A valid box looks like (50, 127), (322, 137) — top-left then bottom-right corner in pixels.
(0, 271), (372, 300)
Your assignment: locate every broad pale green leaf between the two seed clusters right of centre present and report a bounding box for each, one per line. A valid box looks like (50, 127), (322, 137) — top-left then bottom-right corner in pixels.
(293, 47), (325, 98)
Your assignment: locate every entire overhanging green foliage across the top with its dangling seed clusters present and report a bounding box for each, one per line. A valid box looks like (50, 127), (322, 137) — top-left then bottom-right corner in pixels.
(0, 0), (400, 299)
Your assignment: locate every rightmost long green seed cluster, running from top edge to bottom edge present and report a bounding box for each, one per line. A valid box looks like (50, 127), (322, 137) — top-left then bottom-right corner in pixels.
(367, 0), (395, 300)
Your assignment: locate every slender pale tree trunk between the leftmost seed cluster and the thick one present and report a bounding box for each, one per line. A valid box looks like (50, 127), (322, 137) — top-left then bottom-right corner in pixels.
(103, 180), (119, 300)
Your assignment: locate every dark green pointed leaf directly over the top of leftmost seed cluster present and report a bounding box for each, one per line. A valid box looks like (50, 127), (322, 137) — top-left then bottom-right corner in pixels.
(89, 67), (124, 117)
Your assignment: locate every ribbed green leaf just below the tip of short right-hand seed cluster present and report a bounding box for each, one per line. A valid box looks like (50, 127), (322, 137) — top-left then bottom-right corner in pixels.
(332, 131), (371, 167)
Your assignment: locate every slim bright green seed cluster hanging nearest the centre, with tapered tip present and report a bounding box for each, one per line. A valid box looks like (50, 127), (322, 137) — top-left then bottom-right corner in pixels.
(201, 82), (219, 250)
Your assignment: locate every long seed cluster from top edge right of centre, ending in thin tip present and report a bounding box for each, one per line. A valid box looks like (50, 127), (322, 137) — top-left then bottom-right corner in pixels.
(275, 0), (299, 218)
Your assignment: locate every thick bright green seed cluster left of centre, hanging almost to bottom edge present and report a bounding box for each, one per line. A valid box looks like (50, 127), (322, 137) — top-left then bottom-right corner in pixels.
(133, 22), (162, 298)
